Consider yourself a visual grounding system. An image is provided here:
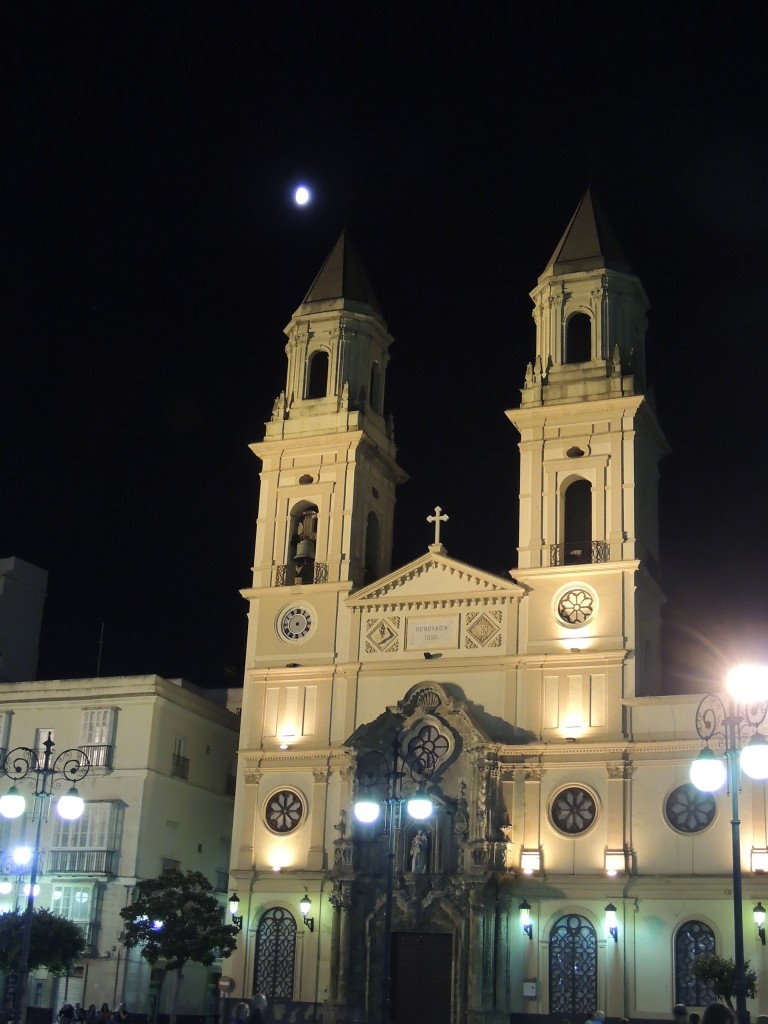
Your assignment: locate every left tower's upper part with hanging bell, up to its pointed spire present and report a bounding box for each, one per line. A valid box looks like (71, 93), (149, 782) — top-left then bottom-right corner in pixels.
(251, 232), (407, 589)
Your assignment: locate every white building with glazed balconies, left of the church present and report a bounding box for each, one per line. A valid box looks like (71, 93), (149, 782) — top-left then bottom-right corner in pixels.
(0, 676), (239, 1016)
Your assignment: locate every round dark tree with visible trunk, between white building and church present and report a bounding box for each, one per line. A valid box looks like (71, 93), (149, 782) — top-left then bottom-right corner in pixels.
(120, 868), (238, 1024)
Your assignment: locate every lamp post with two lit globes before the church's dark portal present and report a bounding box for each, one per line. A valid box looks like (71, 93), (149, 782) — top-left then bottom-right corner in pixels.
(354, 735), (438, 1024)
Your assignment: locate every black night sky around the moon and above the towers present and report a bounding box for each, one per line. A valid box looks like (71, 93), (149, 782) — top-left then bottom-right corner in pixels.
(0, 0), (768, 689)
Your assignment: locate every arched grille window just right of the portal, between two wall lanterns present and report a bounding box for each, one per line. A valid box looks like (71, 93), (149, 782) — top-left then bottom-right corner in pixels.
(549, 913), (597, 1020)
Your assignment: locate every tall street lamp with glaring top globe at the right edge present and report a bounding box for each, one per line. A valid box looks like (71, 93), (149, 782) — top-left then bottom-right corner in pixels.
(690, 666), (768, 1024)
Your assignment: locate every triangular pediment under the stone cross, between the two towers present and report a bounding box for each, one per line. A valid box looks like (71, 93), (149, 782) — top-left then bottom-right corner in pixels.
(347, 551), (525, 606)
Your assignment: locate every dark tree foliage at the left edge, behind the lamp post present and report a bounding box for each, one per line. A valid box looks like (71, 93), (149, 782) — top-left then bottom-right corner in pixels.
(0, 907), (85, 974)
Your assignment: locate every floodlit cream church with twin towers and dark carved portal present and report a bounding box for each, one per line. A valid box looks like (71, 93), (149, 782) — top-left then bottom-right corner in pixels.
(225, 193), (768, 1024)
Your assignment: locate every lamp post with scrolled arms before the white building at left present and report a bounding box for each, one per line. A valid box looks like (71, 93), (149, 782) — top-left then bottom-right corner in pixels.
(0, 733), (90, 1024)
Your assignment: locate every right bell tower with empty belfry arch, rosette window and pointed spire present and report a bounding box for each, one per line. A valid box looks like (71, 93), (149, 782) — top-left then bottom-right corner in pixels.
(507, 191), (667, 696)
